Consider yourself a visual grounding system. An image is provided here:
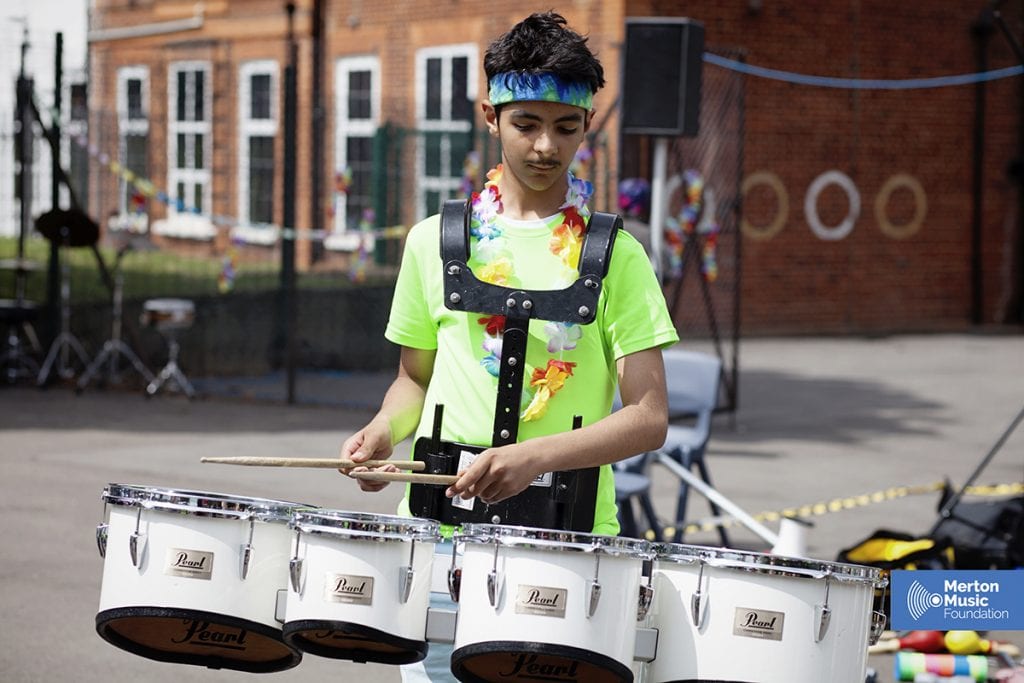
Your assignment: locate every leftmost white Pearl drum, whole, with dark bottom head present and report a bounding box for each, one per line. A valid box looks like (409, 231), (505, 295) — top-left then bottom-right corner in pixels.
(96, 483), (310, 673)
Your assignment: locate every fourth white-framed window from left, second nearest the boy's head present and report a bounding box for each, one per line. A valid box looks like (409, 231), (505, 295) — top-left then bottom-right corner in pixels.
(328, 56), (381, 244)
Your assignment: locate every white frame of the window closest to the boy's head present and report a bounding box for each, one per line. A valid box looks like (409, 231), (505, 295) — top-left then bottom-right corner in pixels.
(416, 43), (478, 220)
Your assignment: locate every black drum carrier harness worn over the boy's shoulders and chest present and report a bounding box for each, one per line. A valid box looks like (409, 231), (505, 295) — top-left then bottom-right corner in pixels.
(409, 200), (623, 531)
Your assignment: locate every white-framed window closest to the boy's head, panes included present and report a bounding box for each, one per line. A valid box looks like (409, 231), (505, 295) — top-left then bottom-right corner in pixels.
(416, 45), (476, 218)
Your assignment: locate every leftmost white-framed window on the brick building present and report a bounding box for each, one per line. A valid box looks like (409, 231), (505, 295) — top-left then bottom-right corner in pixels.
(116, 67), (150, 231)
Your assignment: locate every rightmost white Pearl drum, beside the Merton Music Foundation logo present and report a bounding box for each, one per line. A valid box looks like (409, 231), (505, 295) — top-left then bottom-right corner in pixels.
(646, 544), (886, 683)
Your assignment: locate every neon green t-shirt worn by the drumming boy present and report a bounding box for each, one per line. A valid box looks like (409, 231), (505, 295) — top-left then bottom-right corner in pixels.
(384, 213), (679, 536)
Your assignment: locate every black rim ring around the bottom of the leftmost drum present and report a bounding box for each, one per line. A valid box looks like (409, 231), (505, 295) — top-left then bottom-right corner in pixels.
(96, 606), (302, 674)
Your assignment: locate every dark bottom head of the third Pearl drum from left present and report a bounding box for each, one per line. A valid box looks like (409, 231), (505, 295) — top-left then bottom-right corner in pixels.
(452, 640), (633, 683)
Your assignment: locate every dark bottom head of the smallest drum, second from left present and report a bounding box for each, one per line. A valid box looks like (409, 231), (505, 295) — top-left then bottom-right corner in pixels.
(284, 620), (428, 665)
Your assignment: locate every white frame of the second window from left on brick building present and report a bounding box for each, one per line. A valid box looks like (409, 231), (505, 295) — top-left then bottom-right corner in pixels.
(154, 60), (215, 240)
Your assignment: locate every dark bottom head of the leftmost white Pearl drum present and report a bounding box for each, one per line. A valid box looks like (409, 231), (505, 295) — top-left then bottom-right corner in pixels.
(96, 607), (302, 674)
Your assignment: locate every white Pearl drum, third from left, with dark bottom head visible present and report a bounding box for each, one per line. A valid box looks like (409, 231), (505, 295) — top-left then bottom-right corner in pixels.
(450, 524), (653, 683)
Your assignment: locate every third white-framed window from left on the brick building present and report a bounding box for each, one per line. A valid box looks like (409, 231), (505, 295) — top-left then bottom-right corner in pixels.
(238, 60), (278, 224)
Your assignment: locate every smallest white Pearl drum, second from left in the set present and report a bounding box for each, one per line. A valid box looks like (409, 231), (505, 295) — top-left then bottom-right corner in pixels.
(283, 510), (440, 665)
